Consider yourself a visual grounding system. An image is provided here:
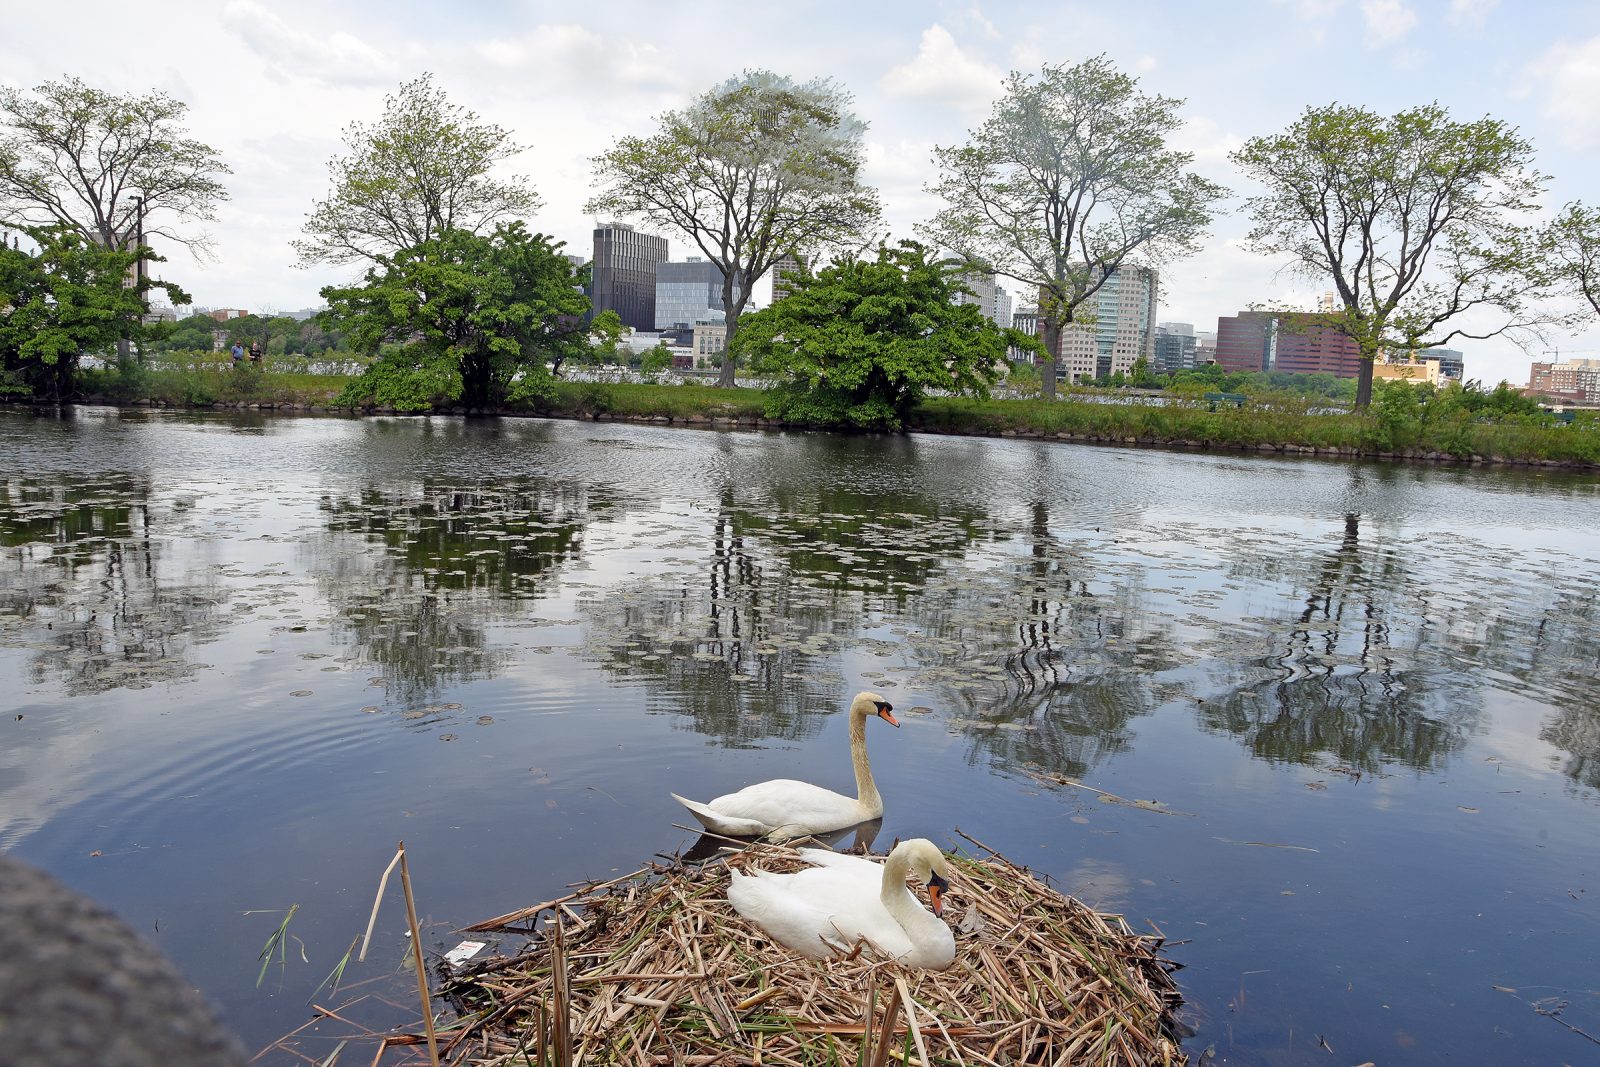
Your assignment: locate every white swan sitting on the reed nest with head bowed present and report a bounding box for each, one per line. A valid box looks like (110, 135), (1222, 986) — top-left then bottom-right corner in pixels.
(728, 837), (955, 971)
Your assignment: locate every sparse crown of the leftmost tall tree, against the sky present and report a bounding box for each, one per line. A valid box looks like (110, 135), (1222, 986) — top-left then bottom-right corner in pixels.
(0, 77), (230, 251)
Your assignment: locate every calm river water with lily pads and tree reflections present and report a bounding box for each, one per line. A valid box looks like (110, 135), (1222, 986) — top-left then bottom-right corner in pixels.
(0, 408), (1600, 1065)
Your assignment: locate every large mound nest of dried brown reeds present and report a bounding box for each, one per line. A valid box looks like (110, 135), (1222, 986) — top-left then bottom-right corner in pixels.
(440, 835), (1186, 1067)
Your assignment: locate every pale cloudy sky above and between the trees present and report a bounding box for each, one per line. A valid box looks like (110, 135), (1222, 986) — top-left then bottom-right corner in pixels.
(0, 0), (1600, 384)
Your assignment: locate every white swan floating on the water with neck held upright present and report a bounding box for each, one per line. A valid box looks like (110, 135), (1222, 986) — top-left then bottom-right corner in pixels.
(672, 693), (899, 838)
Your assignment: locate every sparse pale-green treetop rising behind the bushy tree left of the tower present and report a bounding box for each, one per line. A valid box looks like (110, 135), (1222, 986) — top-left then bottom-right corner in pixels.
(293, 74), (541, 266)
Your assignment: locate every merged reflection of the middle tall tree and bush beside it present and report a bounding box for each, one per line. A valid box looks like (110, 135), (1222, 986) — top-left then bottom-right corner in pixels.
(581, 483), (990, 747)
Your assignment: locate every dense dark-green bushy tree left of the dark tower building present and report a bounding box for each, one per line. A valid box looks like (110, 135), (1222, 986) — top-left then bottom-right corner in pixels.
(322, 222), (589, 411)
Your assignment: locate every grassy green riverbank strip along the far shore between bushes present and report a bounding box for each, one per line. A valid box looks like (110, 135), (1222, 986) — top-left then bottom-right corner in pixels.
(50, 363), (1600, 467)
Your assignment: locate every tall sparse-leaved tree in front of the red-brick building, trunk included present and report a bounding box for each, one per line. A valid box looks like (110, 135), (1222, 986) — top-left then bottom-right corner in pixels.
(1232, 104), (1550, 408)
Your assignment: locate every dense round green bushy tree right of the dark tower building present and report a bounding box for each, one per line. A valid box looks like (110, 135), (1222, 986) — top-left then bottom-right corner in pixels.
(736, 242), (1017, 430)
